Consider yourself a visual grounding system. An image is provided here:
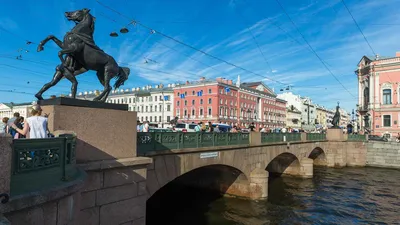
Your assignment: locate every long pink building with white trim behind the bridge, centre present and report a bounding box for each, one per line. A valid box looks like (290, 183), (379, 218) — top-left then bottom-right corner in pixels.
(174, 78), (286, 128)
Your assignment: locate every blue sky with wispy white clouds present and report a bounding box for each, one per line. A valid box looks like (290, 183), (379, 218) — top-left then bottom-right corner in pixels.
(0, 0), (400, 110)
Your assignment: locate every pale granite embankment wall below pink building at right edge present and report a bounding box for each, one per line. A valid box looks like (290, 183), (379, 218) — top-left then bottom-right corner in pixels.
(366, 142), (400, 169)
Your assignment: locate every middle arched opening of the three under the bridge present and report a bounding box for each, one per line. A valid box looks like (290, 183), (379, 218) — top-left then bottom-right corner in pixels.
(266, 152), (300, 177)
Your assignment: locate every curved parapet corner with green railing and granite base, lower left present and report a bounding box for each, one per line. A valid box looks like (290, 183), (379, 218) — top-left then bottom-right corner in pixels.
(0, 135), (86, 224)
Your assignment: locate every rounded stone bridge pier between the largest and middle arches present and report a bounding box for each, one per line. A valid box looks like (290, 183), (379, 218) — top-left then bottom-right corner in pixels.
(249, 168), (269, 200)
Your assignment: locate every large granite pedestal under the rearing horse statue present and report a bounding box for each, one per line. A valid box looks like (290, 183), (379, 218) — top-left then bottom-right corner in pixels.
(39, 98), (136, 163)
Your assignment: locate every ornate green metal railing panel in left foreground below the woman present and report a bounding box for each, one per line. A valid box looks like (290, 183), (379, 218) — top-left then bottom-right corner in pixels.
(11, 135), (77, 195)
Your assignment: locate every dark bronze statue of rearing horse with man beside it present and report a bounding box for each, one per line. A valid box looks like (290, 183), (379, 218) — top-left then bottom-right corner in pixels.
(35, 9), (130, 102)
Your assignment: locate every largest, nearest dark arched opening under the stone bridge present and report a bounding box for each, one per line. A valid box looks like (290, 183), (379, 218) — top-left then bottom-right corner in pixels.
(146, 165), (249, 225)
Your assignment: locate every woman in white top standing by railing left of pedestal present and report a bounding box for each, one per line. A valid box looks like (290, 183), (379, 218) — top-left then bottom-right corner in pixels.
(11, 105), (48, 138)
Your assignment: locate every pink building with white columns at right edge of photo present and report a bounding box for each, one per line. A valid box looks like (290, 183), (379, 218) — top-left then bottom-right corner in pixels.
(356, 52), (400, 138)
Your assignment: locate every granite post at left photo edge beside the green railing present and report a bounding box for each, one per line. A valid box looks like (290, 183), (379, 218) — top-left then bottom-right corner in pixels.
(0, 135), (12, 197)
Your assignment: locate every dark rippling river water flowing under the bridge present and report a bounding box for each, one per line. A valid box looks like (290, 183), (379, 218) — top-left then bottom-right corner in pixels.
(147, 168), (400, 225)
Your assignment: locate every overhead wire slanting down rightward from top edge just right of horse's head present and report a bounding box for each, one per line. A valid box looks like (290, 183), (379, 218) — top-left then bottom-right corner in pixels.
(96, 0), (289, 85)
